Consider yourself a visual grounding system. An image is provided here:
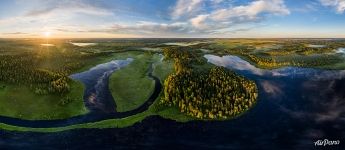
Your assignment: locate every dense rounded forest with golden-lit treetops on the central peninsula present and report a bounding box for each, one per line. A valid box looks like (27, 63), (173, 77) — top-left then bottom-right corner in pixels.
(161, 48), (258, 119)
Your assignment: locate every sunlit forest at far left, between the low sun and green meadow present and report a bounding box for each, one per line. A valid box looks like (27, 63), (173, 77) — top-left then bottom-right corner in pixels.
(0, 45), (105, 95)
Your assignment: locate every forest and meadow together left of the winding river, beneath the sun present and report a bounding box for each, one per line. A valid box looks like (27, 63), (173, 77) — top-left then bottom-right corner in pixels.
(0, 39), (115, 120)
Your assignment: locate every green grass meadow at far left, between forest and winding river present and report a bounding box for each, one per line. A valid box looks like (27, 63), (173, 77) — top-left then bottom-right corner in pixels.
(0, 82), (87, 120)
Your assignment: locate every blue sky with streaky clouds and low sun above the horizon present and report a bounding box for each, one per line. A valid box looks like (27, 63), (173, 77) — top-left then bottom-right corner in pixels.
(0, 0), (345, 38)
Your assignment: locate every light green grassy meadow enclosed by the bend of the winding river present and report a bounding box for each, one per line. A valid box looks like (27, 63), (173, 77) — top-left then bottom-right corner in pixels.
(109, 52), (159, 112)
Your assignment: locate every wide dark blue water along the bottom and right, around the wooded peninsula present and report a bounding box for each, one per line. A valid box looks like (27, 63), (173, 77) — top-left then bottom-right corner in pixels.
(0, 55), (345, 149)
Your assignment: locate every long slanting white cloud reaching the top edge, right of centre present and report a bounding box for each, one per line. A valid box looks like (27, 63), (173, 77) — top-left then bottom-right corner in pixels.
(189, 0), (290, 32)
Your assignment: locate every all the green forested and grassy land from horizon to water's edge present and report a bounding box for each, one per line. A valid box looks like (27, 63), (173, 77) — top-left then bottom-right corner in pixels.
(0, 39), (345, 132)
